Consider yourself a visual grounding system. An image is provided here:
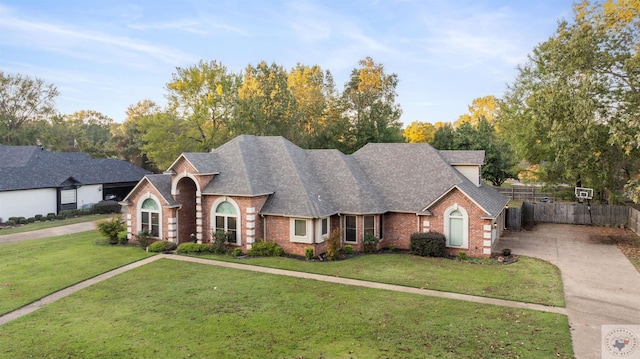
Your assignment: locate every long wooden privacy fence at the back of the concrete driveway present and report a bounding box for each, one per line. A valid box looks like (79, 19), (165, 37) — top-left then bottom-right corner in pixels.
(506, 202), (629, 230)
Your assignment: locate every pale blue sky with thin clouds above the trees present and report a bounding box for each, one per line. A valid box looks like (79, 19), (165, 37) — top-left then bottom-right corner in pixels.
(0, 0), (573, 124)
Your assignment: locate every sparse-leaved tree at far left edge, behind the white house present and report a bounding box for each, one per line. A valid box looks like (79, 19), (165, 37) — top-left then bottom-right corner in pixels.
(0, 71), (58, 145)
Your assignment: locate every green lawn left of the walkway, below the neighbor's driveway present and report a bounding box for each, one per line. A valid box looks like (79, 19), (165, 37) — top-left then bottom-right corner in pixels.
(0, 231), (149, 314)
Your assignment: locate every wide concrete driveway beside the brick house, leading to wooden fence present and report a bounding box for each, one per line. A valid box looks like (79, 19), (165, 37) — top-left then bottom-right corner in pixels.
(499, 224), (640, 359)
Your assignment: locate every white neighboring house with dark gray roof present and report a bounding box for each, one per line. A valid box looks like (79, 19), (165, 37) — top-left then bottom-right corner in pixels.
(0, 145), (151, 222)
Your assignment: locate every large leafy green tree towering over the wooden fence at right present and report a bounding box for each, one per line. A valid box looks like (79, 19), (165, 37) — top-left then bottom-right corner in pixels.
(499, 1), (640, 197)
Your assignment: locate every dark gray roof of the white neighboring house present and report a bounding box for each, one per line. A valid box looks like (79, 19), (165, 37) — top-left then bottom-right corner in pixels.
(0, 145), (151, 191)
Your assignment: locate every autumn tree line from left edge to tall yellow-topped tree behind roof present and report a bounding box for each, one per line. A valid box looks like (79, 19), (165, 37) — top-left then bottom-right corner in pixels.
(0, 57), (403, 171)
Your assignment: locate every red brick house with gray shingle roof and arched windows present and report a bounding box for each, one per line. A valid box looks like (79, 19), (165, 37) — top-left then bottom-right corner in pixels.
(122, 135), (508, 257)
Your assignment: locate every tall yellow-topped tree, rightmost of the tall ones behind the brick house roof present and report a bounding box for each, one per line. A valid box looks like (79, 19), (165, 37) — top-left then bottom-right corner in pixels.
(343, 57), (403, 151)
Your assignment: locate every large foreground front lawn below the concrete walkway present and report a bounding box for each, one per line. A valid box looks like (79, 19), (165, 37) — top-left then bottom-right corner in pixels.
(0, 259), (573, 358)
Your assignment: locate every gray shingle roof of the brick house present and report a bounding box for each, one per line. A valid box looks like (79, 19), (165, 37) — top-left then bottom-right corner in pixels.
(158, 135), (506, 218)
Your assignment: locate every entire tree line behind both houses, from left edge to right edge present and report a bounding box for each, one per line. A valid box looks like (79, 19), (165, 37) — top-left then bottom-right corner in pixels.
(0, 0), (640, 202)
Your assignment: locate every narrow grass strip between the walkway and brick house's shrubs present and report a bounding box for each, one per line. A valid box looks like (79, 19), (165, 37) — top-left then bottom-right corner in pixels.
(203, 254), (565, 307)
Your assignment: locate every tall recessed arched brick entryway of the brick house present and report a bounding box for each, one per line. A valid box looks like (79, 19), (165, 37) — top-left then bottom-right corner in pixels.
(175, 177), (197, 243)
